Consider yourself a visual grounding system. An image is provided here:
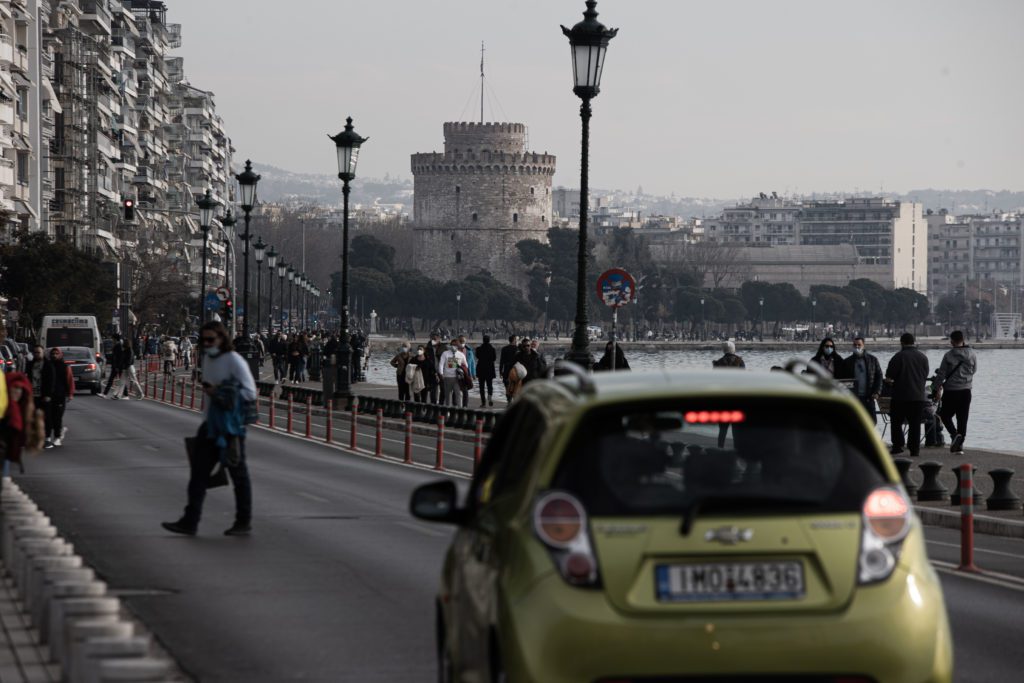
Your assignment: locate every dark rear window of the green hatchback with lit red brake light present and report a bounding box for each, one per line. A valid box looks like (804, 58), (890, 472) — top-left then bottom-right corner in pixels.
(552, 398), (885, 516)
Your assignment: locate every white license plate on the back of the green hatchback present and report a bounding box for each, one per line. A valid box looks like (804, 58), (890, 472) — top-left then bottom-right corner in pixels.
(654, 562), (804, 602)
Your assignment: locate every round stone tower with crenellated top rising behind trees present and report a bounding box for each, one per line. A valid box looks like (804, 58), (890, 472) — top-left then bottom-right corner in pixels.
(412, 123), (555, 285)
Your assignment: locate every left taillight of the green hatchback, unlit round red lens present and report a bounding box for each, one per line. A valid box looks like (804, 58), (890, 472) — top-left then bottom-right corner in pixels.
(534, 490), (599, 587)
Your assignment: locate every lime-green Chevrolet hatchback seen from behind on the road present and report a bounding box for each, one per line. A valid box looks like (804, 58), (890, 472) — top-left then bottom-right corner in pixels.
(411, 361), (952, 683)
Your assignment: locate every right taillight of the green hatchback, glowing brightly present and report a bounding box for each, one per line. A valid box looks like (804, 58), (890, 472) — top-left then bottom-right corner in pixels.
(858, 486), (910, 585)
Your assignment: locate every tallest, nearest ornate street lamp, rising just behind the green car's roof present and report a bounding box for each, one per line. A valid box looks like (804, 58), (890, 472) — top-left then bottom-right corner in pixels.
(562, 0), (618, 370)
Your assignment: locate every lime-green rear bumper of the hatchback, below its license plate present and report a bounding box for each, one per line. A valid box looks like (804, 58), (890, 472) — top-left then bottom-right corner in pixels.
(499, 568), (952, 683)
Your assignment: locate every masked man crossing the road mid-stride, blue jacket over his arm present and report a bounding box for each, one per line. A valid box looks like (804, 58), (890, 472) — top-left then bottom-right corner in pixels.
(162, 322), (256, 536)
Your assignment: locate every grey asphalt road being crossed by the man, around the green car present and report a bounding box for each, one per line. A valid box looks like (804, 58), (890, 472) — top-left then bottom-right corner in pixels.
(12, 396), (1024, 683)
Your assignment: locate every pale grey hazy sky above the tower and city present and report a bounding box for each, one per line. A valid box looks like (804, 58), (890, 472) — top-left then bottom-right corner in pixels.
(167, 0), (1024, 198)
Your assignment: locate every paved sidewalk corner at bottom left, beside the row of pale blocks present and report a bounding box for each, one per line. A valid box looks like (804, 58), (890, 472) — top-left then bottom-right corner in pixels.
(0, 565), (60, 683)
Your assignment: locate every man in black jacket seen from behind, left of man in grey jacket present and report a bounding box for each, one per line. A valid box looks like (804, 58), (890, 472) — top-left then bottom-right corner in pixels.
(886, 332), (928, 458)
